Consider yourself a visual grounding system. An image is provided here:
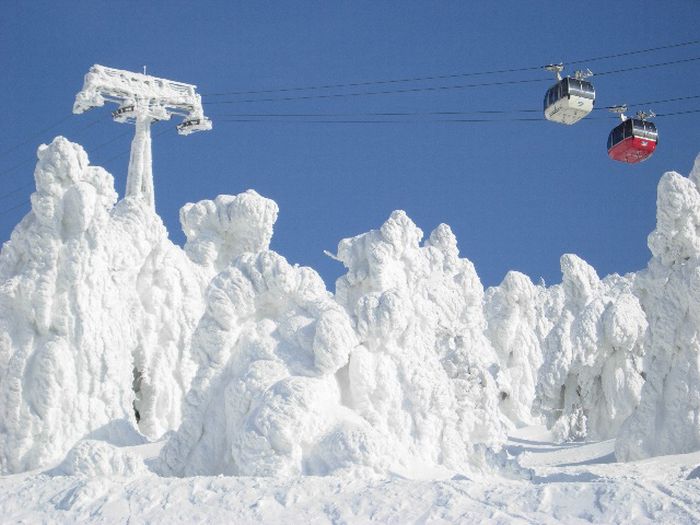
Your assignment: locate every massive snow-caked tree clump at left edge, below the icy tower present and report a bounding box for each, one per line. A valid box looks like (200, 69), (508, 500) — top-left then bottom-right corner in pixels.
(0, 137), (203, 473)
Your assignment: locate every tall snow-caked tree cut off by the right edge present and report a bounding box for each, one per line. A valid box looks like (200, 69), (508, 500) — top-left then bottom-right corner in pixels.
(615, 167), (700, 461)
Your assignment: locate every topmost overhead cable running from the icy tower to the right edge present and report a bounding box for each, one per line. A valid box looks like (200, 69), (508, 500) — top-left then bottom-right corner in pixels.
(202, 40), (700, 97)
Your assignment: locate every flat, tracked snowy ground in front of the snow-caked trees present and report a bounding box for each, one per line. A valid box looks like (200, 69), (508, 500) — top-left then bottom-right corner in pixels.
(0, 427), (700, 524)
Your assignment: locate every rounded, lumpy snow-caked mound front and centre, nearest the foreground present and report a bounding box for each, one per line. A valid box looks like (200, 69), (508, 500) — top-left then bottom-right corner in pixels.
(161, 251), (364, 476)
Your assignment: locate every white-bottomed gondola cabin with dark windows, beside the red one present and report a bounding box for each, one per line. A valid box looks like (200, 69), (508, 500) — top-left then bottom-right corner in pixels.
(544, 64), (595, 125)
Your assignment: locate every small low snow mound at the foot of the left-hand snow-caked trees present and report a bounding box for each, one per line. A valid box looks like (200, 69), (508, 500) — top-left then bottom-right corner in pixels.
(51, 440), (147, 478)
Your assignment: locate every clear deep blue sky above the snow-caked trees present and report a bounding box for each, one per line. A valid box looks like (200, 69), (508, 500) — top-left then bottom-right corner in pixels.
(0, 0), (700, 290)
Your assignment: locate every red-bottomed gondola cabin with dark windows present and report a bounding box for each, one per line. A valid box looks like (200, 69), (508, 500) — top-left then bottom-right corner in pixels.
(608, 106), (659, 164)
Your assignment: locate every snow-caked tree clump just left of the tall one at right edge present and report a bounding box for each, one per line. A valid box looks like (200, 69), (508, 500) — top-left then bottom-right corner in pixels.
(535, 255), (648, 441)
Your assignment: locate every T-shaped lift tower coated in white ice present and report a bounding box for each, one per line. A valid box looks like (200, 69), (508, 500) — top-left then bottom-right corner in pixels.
(73, 64), (212, 208)
